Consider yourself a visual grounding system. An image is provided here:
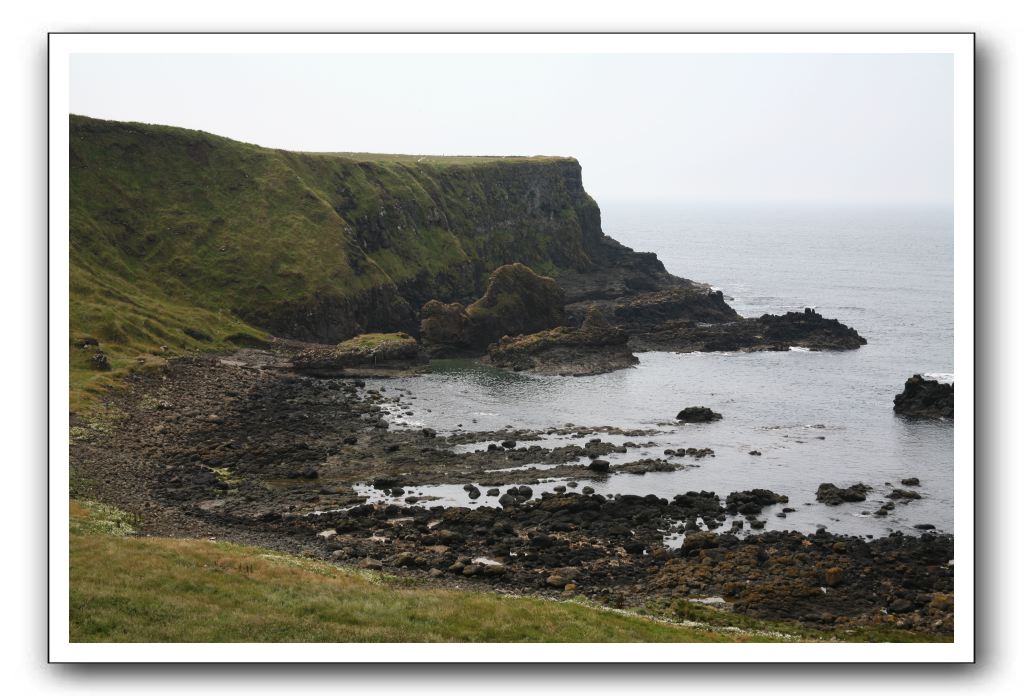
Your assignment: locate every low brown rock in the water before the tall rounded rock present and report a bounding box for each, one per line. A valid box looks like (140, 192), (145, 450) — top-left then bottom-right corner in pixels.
(488, 308), (639, 376)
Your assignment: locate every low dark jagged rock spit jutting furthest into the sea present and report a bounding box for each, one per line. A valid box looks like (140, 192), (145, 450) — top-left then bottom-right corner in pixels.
(630, 308), (866, 353)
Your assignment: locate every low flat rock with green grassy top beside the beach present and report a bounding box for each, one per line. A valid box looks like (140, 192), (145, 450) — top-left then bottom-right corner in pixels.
(292, 333), (427, 378)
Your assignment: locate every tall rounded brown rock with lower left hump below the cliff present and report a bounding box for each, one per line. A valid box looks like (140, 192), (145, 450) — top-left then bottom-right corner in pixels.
(419, 263), (565, 357)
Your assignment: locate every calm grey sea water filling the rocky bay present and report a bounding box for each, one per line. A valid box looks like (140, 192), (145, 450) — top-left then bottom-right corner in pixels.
(364, 204), (954, 541)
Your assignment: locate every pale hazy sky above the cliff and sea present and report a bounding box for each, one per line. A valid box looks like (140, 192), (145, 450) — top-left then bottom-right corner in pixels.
(71, 54), (952, 207)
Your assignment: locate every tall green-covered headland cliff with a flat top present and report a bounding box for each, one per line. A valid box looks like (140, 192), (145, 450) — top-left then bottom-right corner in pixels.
(70, 116), (681, 352)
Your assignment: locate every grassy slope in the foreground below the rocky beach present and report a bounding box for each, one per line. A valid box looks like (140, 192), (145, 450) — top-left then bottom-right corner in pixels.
(71, 502), (776, 643)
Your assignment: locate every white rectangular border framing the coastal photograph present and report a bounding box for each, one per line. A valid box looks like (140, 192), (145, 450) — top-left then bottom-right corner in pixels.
(48, 33), (975, 663)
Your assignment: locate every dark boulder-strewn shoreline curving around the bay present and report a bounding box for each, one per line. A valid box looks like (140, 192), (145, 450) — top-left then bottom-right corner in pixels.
(71, 342), (953, 633)
